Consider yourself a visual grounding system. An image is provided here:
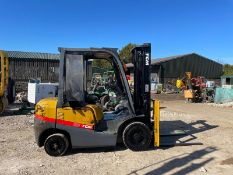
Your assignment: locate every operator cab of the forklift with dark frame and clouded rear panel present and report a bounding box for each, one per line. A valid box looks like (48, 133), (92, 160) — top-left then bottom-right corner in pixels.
(58, 50), (132, 123)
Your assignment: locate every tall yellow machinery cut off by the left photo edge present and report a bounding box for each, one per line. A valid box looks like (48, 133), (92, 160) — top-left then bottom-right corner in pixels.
(0, 51), (9, 113)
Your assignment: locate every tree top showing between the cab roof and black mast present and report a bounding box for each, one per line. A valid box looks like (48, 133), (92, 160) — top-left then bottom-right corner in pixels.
(119, 43), (136, 63)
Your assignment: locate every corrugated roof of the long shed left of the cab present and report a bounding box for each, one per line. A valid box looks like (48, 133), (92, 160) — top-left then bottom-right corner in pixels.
(6, 51), (60, 60)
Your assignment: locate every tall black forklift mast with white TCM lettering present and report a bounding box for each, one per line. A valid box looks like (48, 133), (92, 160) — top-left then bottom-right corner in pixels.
(132, 43), (151, 122)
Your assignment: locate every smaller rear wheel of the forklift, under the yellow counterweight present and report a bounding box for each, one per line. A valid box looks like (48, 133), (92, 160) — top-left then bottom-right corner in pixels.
(44, 133), (69, 156)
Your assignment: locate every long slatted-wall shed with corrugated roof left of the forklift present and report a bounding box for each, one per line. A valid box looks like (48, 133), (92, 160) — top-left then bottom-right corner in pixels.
(6, 51), (60, 91)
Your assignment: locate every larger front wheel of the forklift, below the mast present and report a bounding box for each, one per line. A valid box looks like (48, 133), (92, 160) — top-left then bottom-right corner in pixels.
(123, 122), (151, 151)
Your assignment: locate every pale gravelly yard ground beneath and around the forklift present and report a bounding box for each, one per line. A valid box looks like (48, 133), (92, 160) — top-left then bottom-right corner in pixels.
(0, 94), (233, 175)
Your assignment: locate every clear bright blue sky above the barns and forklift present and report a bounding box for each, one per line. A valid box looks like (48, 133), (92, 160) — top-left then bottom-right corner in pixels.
(0, 0), (233, 64)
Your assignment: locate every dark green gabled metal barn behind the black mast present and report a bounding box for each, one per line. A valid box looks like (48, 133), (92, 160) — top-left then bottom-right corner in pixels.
(127, 53), (223, 84)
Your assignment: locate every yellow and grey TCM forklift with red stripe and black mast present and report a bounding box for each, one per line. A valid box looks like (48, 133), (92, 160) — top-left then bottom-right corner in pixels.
(34, 43), (159, 156)
